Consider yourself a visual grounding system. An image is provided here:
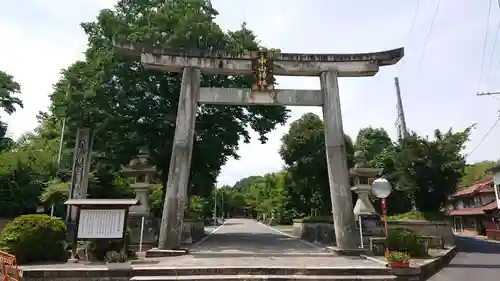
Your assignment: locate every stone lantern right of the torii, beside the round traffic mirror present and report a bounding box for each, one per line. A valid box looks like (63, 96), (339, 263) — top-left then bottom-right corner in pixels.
(349, 151), (383, 236)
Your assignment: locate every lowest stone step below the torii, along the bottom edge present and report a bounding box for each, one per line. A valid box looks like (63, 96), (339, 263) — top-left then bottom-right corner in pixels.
(130, 275), (396, 281)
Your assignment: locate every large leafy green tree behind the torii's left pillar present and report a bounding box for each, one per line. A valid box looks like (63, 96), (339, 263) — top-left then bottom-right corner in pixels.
(50, 0), (288, 201)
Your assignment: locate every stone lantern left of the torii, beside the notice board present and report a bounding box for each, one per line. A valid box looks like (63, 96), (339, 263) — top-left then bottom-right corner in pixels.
(122, 148), (156, 250)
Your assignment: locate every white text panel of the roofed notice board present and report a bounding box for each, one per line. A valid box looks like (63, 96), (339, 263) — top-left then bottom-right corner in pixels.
(77, 209), (125, 239)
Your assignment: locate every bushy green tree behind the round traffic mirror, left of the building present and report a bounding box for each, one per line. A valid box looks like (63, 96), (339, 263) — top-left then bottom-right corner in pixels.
(374, 128), (470, 212)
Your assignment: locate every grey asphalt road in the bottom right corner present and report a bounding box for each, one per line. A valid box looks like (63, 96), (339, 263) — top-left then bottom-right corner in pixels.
(429, 237), (500, 281)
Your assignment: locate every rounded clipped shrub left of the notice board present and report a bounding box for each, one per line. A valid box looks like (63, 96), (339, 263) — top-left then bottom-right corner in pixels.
(0, 214), (68, 263)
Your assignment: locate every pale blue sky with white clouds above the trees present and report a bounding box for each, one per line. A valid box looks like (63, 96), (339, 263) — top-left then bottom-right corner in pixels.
(0, 0), (500, 184)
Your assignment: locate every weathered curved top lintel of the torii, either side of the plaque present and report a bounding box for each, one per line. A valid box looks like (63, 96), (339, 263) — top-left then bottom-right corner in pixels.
(114, 41), (404, 77)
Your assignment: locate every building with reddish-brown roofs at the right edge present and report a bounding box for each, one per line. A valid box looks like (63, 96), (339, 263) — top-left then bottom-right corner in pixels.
(445, 178), (500, 235)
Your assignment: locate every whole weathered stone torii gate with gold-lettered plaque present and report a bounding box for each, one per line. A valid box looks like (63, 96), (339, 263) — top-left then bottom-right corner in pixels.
(115, 42), (404, 250)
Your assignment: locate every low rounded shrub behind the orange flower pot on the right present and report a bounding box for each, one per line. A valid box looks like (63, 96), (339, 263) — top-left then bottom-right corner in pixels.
(387, 228), (427, 257)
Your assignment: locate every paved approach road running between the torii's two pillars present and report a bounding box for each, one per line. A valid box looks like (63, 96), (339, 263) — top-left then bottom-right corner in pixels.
(191, 219), (327, 255)
